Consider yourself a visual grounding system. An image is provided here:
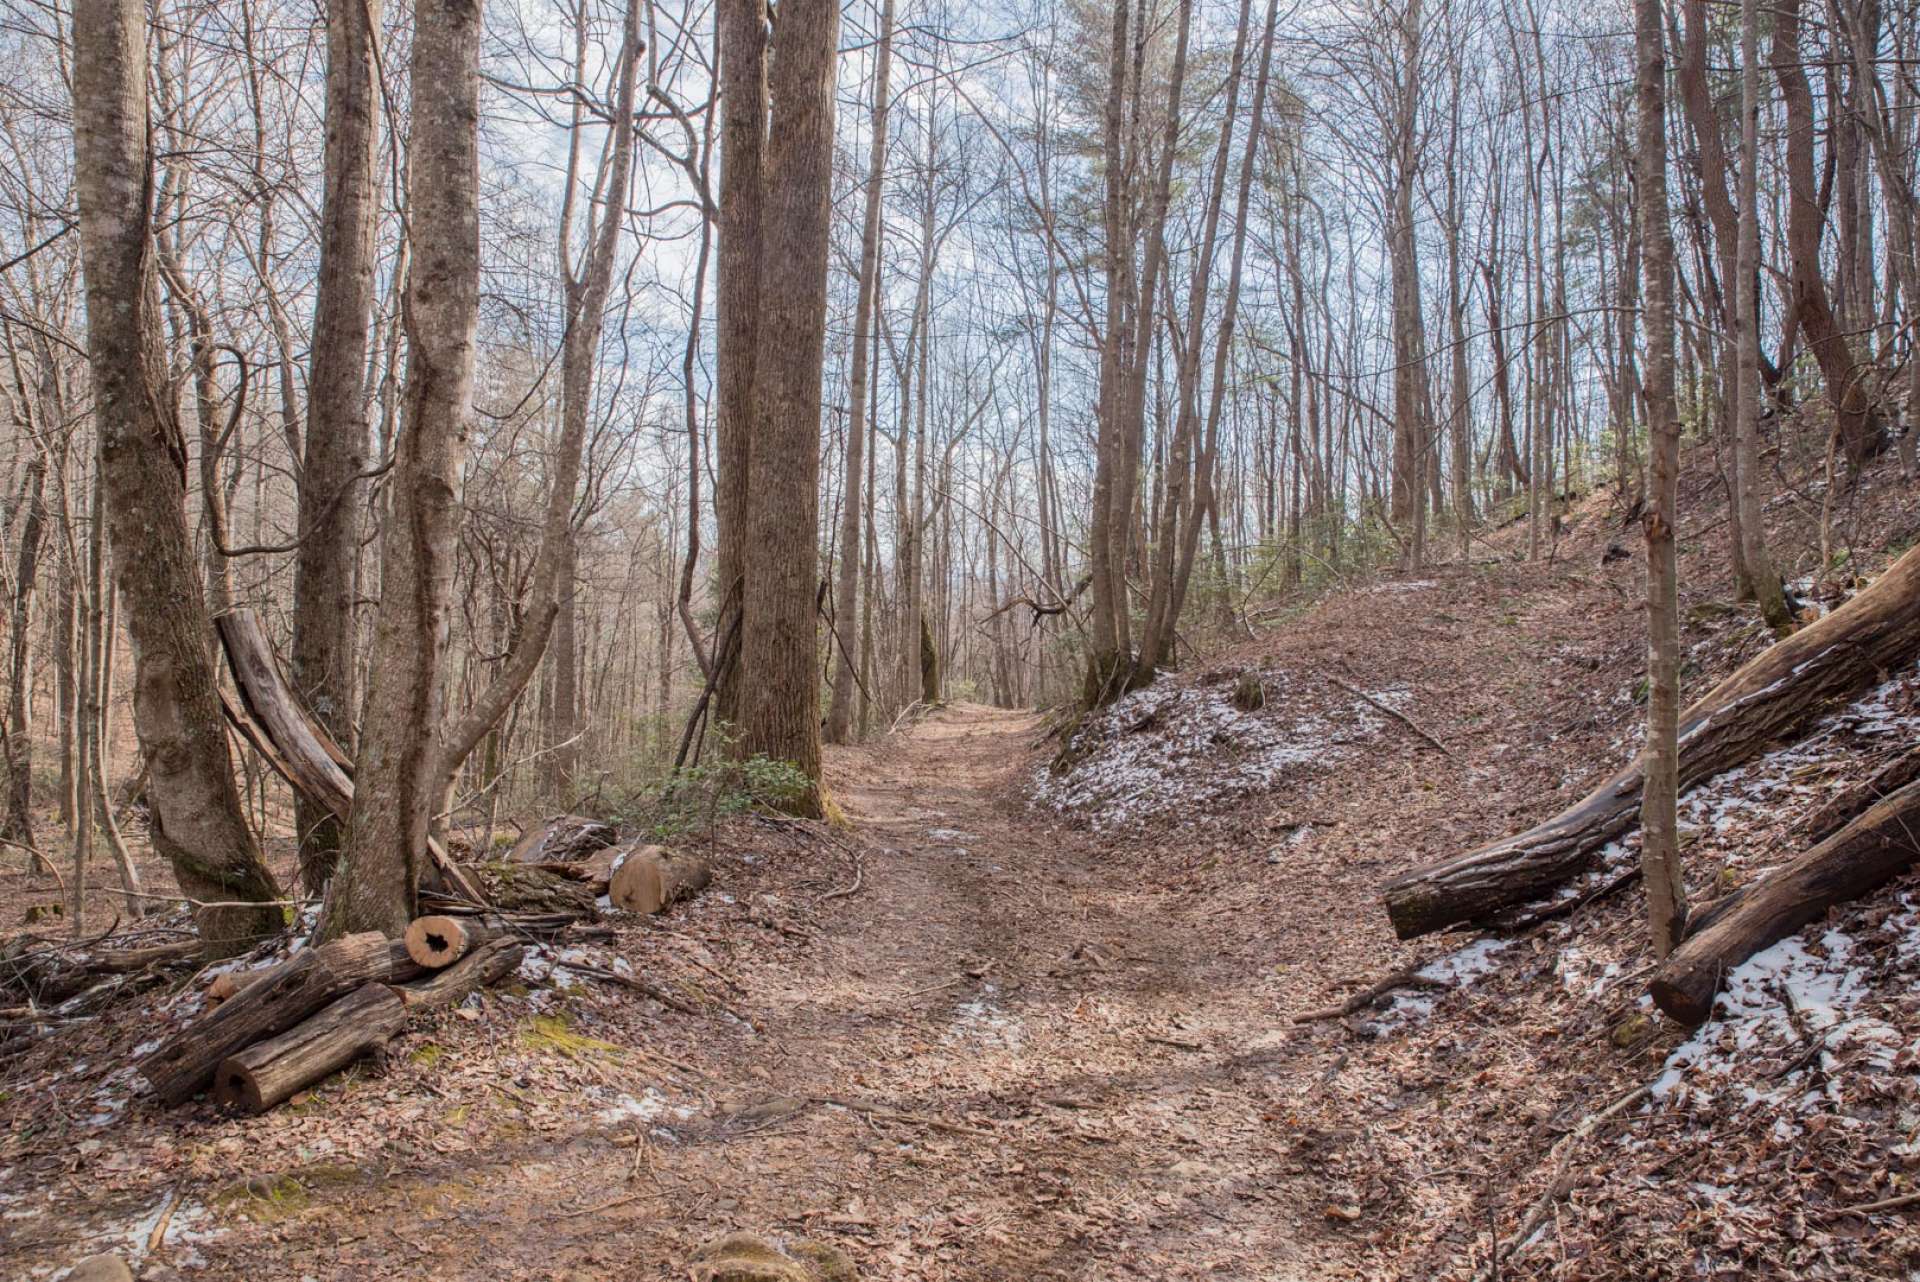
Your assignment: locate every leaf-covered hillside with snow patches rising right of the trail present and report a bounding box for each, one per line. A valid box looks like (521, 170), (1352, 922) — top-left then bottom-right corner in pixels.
(1029, 454), (1920, 1278)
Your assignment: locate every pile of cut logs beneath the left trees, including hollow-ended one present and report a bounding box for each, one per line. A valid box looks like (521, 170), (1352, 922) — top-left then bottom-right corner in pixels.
(136, 832), (710, 1113)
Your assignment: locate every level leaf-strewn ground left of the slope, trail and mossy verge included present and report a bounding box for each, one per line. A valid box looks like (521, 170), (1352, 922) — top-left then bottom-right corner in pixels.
(0, 704), (1382, 1282)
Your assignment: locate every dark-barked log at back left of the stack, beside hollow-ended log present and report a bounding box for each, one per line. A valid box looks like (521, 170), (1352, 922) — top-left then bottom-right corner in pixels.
(136, 931), (394, 1104)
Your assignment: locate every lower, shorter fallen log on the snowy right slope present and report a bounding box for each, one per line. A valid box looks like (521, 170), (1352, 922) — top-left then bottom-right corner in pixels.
(1651, 783), (1920, 1025)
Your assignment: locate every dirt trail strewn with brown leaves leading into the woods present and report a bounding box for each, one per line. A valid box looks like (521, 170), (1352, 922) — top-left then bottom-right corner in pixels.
(78, 704), (1354, 1282)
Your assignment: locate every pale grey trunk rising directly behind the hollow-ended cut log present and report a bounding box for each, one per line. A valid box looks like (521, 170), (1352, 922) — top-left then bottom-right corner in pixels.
(321, 0), (480, 938)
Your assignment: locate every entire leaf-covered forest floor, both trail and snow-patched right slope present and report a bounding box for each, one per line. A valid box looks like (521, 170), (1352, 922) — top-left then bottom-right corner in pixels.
(11, 445), (1920, 1282)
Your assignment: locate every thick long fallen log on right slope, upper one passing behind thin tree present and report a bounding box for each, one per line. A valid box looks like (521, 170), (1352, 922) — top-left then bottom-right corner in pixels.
(1380, 547), (1920, 938)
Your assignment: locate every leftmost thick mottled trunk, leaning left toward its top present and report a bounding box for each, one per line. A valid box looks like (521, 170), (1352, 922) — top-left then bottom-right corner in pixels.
(73, 0), (280, 956)
